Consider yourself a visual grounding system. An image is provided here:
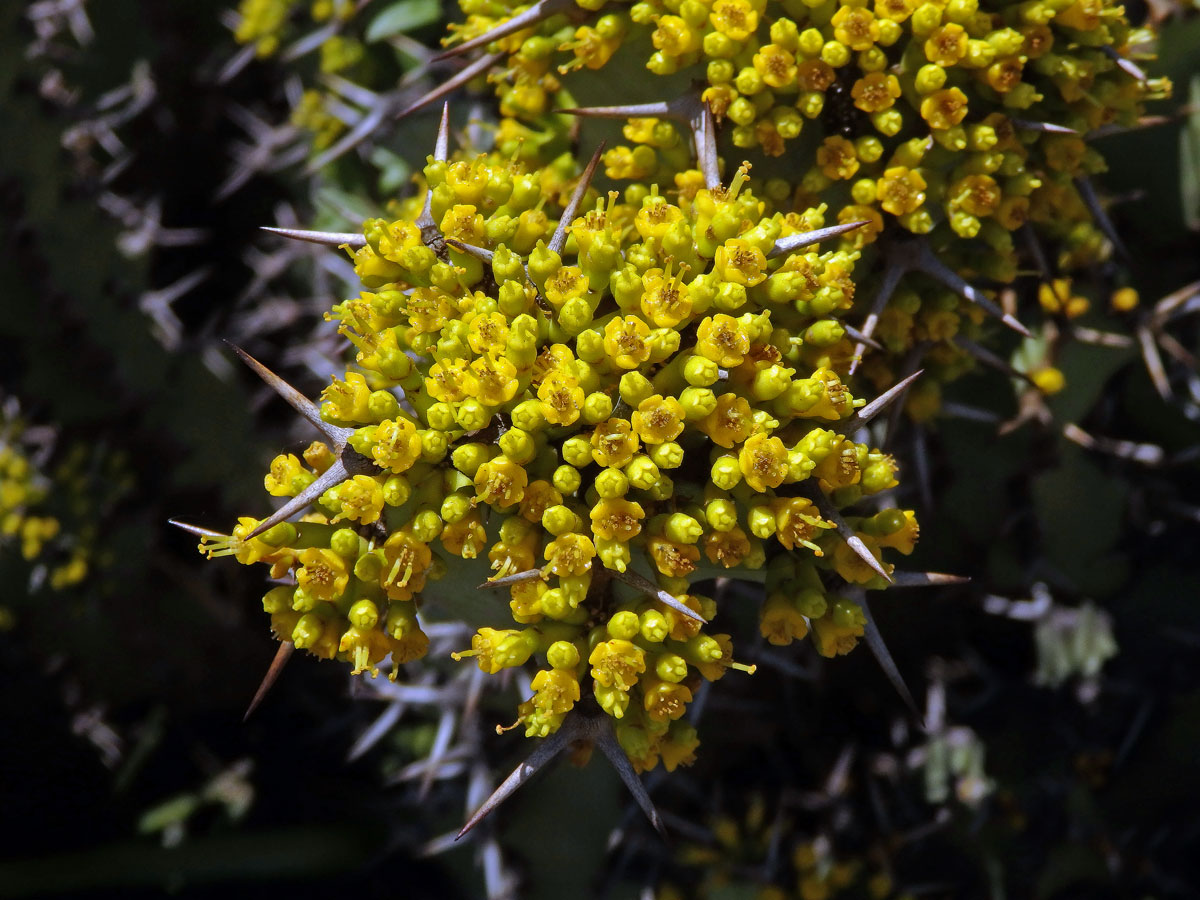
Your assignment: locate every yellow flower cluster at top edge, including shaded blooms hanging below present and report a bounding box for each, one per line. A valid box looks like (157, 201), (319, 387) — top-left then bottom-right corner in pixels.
(432, 0), (1170, 408)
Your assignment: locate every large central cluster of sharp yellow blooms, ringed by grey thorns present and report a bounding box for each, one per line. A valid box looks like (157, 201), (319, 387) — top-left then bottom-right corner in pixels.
(202, 144), (918, 769)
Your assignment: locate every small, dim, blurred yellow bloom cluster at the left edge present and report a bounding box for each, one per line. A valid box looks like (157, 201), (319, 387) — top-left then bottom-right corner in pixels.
(0, 409), (95, 590)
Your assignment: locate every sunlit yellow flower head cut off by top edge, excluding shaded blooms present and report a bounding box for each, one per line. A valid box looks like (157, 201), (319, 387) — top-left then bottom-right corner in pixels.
(450, 0), (1163, 256)
